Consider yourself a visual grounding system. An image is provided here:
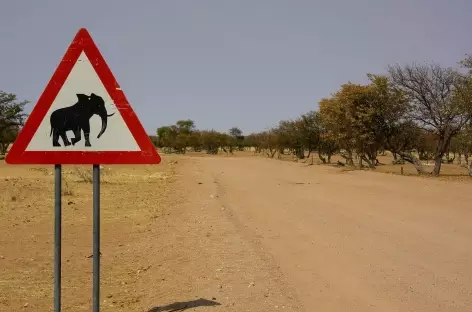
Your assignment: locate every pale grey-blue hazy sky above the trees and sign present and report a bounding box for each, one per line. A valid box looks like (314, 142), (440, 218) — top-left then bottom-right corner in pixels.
(0, 0), (472, 134)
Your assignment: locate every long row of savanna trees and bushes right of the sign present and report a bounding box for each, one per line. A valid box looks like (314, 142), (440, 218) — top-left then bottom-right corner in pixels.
(154, 56), (472, 176)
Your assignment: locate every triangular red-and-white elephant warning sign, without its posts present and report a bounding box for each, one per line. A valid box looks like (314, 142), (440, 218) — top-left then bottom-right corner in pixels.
(5, 28), (161, 164)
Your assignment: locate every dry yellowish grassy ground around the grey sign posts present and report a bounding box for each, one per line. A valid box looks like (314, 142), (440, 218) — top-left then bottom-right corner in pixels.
(0, 157), (175, 311)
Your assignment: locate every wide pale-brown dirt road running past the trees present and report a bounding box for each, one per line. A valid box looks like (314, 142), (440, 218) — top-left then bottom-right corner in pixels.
(157, 157), (472, 312)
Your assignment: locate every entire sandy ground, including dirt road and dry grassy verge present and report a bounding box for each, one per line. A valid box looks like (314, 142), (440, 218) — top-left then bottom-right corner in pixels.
(0, 152), (472, 312)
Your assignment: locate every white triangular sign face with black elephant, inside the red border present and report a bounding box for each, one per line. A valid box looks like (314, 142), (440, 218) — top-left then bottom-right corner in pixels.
(26, 52), (141, 152)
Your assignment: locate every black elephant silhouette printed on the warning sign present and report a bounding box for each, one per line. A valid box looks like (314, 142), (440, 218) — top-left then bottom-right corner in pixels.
(49, 93), (115, 146)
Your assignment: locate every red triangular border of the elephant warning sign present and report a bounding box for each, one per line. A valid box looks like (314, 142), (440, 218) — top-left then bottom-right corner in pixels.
(5, 28), (161, 164)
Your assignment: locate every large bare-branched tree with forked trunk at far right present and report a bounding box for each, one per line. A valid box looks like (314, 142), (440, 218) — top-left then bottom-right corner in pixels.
(388, 64), (472, 176)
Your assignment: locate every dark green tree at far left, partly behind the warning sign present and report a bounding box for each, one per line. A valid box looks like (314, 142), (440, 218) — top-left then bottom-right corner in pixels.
(0, 91), (29, 154)
